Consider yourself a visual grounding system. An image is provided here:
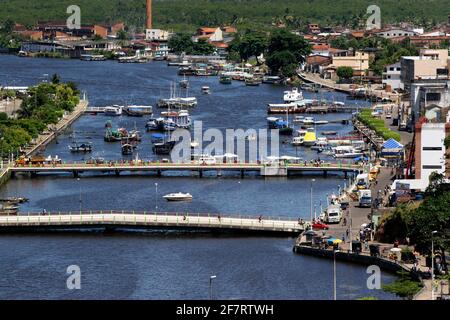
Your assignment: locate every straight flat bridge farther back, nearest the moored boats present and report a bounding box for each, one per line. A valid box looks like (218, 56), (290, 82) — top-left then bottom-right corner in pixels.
(8, 161), (365, 177)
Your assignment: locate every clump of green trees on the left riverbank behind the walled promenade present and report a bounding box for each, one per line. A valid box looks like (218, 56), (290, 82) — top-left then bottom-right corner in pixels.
(0, 75), (80, 157)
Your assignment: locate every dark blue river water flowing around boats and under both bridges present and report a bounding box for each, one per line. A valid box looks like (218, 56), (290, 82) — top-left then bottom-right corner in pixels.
(0, 56), (395, 299)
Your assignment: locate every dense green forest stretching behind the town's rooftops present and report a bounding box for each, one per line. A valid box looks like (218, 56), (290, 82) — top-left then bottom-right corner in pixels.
(0, 0), (450, 31)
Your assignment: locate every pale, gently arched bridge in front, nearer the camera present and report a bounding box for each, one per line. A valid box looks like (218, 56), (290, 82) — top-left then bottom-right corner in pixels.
(0, 211), (304, 236)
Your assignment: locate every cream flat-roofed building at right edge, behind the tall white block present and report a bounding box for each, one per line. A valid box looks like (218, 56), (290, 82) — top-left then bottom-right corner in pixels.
(400, 49), (448, 90)
